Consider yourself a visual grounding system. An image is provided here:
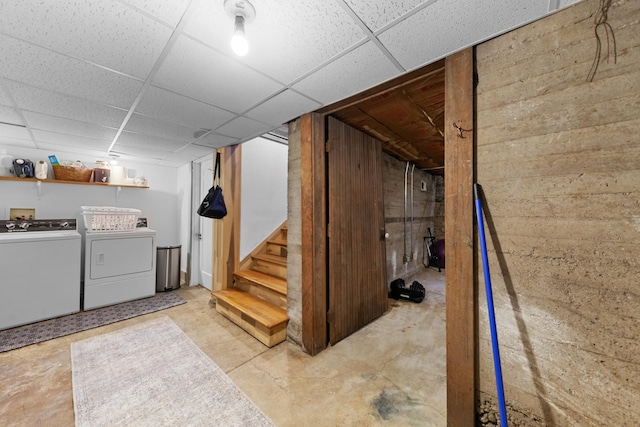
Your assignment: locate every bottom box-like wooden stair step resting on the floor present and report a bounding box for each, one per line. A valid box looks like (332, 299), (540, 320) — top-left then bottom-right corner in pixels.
(213, 288), (289, 347)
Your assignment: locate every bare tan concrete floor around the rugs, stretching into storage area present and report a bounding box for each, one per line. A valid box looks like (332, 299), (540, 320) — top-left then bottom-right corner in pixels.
(0, 270), (446, 426)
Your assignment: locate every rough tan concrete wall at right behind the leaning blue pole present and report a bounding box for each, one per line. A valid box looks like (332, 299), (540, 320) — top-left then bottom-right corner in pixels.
(476, 0), (640, 427)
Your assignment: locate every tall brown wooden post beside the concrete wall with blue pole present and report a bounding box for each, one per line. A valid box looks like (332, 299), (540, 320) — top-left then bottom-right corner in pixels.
(444, 48), (475, 427)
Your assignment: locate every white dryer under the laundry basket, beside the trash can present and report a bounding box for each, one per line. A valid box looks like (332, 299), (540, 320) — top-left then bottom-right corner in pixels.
(82, 227), (156, 310)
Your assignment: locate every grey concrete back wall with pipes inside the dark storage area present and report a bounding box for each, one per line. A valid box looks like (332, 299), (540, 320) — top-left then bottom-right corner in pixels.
(383, 154), (444, 284)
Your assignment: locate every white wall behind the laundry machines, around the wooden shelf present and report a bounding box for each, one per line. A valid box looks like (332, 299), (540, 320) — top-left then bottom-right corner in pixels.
(0, 145), (180, 246)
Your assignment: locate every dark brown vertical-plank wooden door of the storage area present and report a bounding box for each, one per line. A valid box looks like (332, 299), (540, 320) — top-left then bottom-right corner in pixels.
(327, 117), (388, 344)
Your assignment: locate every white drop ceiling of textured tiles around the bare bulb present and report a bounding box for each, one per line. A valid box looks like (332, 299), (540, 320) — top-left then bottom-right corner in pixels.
(0, 0), (575, 167)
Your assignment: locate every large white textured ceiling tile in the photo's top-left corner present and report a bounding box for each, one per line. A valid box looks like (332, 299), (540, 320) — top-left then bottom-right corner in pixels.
(0, 0), (172, 79)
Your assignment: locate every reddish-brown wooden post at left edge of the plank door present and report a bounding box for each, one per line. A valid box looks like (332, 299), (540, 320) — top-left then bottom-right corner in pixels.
(300, 113), (327, 356)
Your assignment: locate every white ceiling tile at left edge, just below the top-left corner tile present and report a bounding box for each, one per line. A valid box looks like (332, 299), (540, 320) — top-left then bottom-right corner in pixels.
(0, 35), (142, 109)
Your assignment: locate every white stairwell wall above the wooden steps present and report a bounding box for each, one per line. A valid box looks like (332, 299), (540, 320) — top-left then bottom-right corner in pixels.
(240, 138), (289, 259)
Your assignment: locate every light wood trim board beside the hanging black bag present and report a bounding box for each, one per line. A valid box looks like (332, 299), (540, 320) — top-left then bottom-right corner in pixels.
(211, 145), (242, 293)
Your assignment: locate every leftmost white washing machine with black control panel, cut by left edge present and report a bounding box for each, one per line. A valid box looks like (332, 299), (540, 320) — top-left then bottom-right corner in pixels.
(0, 219), (81, 330)
